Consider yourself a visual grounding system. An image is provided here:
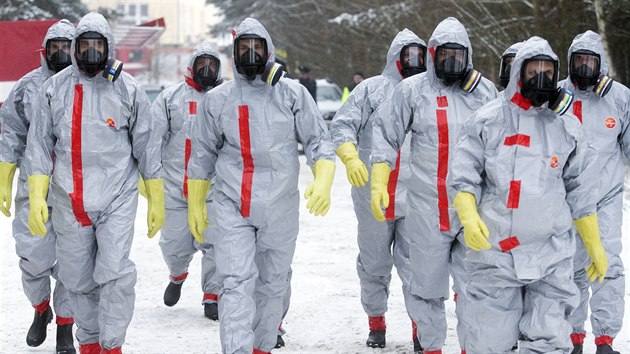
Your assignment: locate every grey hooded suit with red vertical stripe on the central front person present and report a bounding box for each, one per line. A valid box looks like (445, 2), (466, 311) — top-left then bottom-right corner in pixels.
(188, 18), (335, 354)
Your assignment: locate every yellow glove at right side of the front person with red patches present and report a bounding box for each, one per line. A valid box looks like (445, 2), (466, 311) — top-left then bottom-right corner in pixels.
(573, 213), (608, 283)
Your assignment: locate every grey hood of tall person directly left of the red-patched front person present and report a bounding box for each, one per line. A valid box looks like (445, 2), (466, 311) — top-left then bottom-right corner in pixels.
(427, 17), (473, 87)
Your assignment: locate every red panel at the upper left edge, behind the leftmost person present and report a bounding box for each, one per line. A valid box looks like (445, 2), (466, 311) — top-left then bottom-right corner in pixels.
(0, 20), (59, 81)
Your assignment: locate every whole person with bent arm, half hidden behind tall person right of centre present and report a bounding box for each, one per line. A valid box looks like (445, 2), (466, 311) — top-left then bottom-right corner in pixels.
(330, 29), (427, 351)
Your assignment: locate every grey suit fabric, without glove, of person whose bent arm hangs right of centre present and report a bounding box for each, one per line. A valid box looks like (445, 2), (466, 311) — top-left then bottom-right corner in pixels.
(330, 28), (426, 316)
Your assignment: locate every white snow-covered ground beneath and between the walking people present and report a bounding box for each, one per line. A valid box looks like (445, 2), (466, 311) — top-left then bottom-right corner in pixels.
(0, 156), (630, 354)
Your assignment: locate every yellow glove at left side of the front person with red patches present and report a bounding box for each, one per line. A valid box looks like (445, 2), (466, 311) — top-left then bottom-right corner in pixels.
(453, 192), (491, 251)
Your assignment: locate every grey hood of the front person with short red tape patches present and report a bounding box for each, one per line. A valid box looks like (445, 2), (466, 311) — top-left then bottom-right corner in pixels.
(503, 36), (558, 110)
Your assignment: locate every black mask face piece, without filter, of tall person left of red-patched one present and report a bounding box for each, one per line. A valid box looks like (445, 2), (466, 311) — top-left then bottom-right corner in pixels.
(435, 43), (468, 86)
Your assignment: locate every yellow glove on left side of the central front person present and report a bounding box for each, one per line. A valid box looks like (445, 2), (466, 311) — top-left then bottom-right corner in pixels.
(188, 179), (210, 243)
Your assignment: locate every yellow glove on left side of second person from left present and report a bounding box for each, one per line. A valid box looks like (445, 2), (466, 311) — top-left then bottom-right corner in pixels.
(28, 175), (50, 236)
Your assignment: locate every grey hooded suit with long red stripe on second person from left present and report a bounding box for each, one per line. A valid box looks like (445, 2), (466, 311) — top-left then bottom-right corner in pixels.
(23, 12), (161, 349)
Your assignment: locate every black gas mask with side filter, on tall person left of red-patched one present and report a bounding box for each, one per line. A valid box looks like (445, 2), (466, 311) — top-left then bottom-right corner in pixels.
(435, 43), (482, 93)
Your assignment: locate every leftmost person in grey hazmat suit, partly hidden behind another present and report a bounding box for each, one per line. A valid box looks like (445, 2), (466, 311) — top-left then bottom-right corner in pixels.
(0, 19), (75, 354)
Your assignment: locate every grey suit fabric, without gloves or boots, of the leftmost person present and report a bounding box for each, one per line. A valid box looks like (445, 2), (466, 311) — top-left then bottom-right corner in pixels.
(0, 20), (74, 321)
